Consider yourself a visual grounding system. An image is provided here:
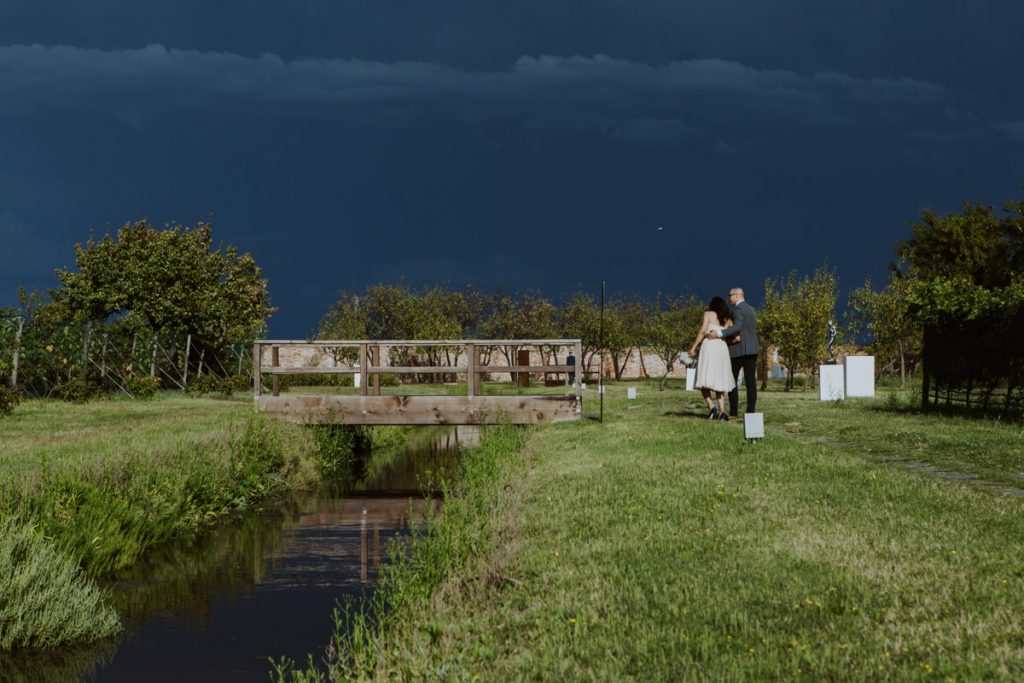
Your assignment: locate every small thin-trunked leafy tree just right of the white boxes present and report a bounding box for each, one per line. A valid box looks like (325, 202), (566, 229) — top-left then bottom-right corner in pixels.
(847, 269), (922, 390)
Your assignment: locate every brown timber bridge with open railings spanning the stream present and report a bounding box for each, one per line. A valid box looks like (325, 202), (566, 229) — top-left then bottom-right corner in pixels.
(253, 339), (583, 425)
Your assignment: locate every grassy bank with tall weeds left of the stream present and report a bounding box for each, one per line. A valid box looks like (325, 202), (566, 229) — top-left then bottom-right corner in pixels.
(0, 396), (319, 649)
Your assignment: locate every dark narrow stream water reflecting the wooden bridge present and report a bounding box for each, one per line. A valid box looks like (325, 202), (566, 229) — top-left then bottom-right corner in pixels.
(0, 429), (476, 683)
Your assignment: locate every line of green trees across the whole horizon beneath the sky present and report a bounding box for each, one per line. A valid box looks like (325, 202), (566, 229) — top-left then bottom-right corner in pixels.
(0, 188), (1024, 411)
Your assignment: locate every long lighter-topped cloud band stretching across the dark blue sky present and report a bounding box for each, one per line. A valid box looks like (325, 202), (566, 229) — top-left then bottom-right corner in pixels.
(0, 45), (966, 145)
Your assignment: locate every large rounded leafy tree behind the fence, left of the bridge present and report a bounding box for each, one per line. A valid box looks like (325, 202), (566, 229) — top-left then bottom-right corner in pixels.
(51, 221), (274, 349)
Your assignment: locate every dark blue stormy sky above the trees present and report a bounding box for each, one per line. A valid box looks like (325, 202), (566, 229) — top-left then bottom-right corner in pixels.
(0, 0), (1024, 336)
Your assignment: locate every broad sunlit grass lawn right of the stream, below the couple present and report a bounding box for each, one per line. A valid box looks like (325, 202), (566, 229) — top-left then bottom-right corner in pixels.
(282, 386), (1024, 681)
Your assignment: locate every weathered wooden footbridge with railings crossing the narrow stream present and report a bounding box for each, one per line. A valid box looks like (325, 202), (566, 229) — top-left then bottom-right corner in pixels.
(253, 339), (583, 425)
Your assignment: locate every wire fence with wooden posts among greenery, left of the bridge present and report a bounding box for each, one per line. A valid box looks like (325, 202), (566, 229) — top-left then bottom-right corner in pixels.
(0, 317), (252, 398)
